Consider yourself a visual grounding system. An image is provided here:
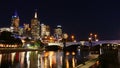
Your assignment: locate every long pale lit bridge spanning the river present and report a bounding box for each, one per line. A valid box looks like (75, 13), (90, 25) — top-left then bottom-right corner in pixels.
(48, 40), (120, 47)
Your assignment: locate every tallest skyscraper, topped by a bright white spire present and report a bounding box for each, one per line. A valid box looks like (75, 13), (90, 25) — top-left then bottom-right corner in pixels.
(31, 12), (40, 40)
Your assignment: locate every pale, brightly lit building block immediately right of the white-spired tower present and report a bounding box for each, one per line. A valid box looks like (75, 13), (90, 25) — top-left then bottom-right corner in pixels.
(41, 24), (50, 38)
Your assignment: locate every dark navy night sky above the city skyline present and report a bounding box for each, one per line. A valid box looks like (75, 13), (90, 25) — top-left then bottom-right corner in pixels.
(0, 0), (120, 40)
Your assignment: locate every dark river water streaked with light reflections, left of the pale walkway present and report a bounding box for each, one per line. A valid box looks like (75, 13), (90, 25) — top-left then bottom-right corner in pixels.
(0, 50), (89, 68)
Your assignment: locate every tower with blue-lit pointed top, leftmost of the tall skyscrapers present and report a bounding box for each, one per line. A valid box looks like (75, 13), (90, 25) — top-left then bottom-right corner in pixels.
(11, 11), (20, 34)
